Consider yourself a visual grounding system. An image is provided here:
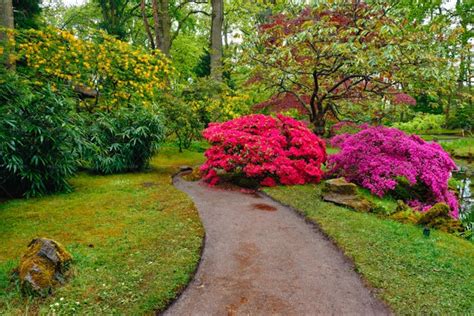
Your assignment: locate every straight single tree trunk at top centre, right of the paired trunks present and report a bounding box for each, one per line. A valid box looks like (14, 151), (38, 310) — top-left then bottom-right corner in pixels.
(211, 0), (224, 81)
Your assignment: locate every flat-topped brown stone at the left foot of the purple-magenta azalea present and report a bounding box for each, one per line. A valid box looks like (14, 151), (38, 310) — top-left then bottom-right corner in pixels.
(323, 178), (374, 212)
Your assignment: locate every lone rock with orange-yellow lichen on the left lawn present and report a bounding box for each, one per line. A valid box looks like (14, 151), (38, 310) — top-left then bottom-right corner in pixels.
(16, 238), (72, 296)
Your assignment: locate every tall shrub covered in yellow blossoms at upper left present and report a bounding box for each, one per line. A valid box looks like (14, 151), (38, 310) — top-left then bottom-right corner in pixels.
(16, 28), (172, 109)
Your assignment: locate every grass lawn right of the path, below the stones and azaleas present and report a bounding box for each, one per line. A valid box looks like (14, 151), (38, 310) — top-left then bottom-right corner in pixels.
(265, 185), (474, 315)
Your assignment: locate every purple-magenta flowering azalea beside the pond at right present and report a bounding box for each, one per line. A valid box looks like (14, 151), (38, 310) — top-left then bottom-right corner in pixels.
(328, 126), (459, 218)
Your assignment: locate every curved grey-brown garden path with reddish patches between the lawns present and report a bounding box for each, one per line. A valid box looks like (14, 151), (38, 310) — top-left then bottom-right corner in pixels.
(164, 177), (390, 315)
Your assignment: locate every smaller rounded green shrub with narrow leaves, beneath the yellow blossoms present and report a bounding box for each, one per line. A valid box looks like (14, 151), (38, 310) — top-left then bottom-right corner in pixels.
(83, 107), (164, 174)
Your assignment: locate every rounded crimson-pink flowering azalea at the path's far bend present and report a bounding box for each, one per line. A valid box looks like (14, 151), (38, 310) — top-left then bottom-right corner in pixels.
(201, 114), (326, 186)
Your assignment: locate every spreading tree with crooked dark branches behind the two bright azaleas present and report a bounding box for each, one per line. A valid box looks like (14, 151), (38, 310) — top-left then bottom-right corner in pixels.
(244, 0), (453, 135)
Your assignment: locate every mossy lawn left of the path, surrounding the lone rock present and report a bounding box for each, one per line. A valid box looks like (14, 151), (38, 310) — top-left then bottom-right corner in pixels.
(0, 147), (204, 315)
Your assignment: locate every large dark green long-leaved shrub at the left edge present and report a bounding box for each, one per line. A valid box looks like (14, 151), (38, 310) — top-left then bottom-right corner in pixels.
(0, 71), (81, 197)
